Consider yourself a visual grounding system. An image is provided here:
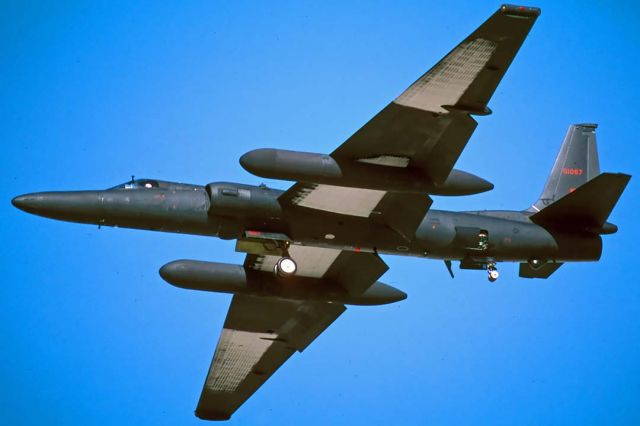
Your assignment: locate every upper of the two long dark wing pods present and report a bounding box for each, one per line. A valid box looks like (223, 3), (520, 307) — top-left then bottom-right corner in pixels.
(240, 148), (493, 195)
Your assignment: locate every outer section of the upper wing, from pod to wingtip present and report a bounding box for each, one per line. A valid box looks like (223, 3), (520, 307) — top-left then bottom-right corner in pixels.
(331, 5), (540, 184)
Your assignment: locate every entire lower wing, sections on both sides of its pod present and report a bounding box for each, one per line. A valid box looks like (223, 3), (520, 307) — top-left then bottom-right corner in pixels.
(196, 246), (387, 420)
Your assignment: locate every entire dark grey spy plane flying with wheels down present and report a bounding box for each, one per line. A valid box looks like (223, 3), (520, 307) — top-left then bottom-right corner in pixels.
(13, 5), (630, 420)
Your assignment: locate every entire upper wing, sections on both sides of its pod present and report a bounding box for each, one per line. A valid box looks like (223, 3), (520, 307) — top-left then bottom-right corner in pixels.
(280, 6), (540, 231)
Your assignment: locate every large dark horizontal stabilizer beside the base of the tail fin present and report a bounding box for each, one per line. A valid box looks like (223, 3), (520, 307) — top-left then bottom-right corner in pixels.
(531, 173), (631, 232)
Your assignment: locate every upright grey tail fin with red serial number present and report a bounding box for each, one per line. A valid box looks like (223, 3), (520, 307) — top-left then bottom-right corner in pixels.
(529, 124), (600, 212)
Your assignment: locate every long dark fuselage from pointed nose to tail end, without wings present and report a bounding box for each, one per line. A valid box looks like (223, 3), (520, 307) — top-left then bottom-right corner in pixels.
(13, 180), (602, 263)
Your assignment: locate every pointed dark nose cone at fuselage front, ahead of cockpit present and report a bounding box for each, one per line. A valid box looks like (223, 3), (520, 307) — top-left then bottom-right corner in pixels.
(11, 191), (101, 223)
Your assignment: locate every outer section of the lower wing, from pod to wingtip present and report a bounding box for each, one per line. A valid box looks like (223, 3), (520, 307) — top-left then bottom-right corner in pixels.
(196, 295), (346, 420)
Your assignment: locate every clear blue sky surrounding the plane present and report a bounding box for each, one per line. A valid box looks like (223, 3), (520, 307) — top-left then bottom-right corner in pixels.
(0, 1), (640, 425)
